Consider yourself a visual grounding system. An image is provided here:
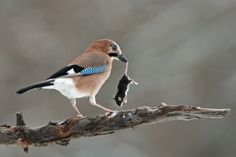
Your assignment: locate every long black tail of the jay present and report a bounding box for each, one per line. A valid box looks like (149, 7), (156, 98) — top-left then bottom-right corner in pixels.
(16, 79), (54, 94)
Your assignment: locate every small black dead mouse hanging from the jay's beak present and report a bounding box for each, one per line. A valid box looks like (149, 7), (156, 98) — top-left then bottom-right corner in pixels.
(113, 74), (138, 106)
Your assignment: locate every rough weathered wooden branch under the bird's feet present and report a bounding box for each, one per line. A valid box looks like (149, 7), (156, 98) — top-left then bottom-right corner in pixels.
(0, 103), (230, 152)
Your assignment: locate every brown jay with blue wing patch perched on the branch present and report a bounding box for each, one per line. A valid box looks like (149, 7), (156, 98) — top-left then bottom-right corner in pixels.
(16, 39), (128, 117)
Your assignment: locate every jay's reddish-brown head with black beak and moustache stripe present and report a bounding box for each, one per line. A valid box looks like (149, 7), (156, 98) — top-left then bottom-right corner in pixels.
(86, 39), (128, 63)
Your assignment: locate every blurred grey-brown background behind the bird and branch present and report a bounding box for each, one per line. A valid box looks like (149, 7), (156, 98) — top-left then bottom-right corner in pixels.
(0, 0), (236, 157)
